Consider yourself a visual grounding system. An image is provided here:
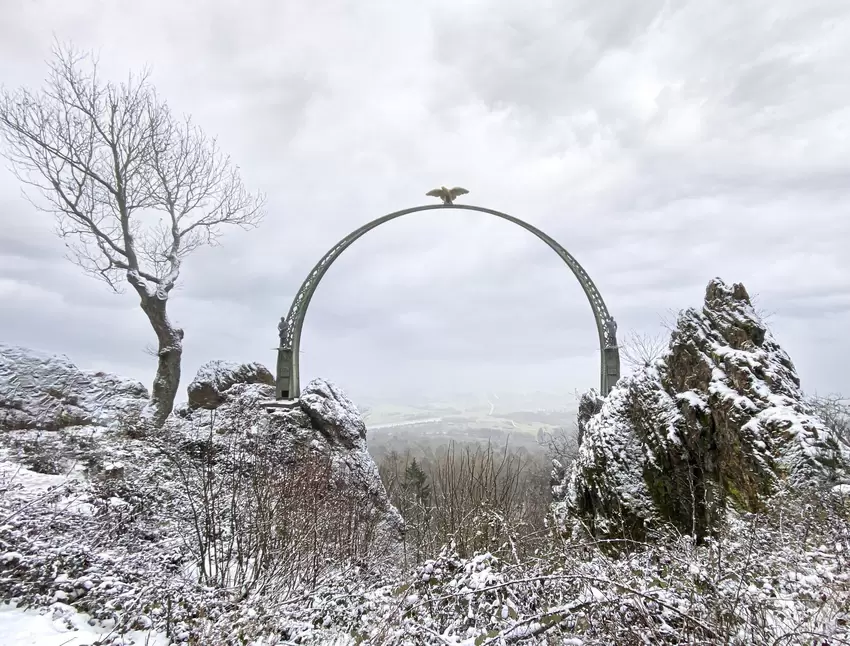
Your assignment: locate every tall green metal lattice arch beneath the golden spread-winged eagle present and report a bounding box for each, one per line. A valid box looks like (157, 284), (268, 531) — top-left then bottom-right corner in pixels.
(276, 204), (620, 399)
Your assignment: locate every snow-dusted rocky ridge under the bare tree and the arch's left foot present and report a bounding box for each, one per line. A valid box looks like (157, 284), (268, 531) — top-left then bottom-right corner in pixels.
(0, 346), (404, 563)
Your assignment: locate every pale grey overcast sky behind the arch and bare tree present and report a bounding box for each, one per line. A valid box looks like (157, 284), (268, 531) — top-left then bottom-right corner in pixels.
(0, 0), (850, 398)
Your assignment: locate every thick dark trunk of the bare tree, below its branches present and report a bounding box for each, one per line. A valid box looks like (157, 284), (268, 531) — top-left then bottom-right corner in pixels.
(141, 294), (183, 427)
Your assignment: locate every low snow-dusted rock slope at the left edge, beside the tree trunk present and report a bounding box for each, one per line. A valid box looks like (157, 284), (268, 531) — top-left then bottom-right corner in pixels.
(0, 344), (148, 431)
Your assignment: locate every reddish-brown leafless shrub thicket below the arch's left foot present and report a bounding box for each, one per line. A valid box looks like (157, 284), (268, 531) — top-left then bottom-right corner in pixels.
(151, 412), (379, 598)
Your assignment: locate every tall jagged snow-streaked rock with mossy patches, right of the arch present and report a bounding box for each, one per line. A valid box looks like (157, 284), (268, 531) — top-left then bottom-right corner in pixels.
(554, 279), (850, 539)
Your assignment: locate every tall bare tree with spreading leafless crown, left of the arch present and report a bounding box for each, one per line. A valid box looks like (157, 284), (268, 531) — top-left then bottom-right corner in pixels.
(0, 45), (264, 424)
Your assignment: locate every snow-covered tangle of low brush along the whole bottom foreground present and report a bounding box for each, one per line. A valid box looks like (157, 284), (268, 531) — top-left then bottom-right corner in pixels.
(0, 474), (850, 646)
